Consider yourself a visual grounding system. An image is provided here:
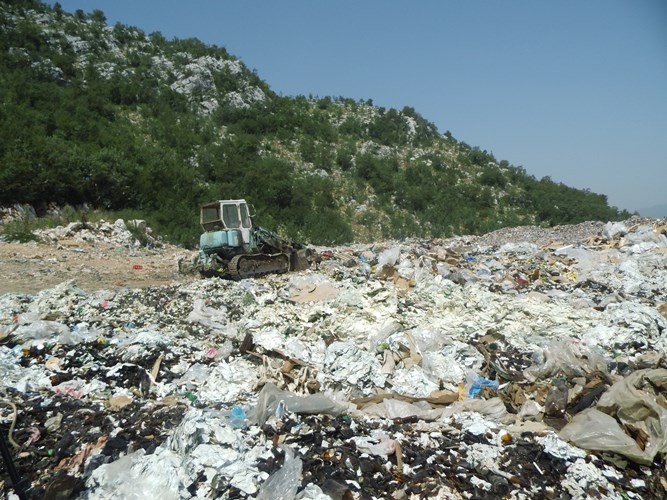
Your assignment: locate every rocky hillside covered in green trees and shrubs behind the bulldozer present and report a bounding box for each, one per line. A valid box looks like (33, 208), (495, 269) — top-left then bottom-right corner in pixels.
(0, 0), (629, 245)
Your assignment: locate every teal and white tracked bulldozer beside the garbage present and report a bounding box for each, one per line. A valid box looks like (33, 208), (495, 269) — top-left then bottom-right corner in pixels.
(190, 200), (310, 280)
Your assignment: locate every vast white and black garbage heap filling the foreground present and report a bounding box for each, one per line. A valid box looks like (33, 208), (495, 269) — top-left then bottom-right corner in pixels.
(0, 219), (667, 500)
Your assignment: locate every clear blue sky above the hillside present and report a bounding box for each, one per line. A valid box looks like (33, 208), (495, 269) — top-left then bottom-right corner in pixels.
(48, 0), (667, 215)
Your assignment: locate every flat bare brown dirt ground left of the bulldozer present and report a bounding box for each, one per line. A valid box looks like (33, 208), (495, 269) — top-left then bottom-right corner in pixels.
(0, 240), (197, 294)
